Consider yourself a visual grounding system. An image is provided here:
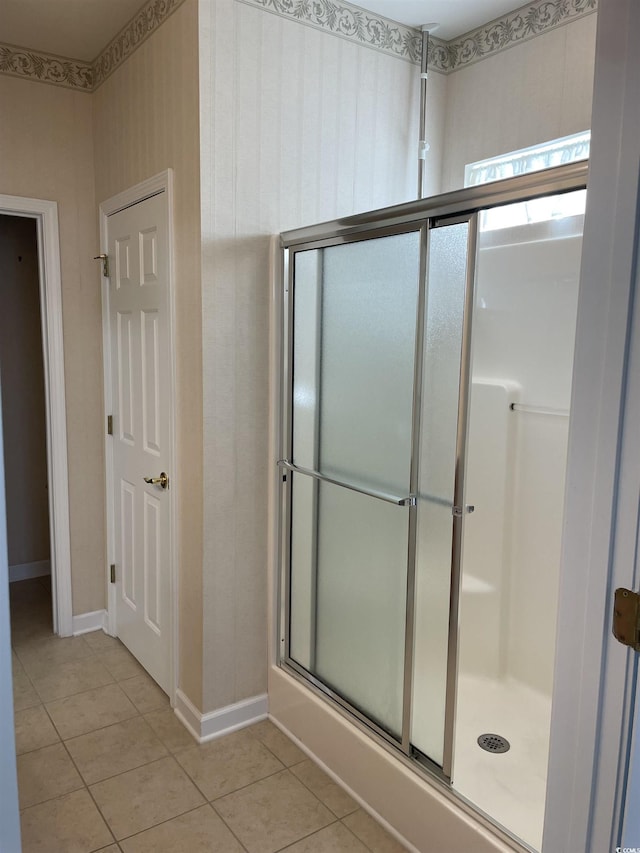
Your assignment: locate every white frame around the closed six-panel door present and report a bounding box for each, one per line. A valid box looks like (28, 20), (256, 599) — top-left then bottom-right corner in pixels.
(100, 169), (180, 706)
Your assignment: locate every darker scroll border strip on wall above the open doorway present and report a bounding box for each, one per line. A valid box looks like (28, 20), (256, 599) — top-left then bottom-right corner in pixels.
(0, 44), (93, 92)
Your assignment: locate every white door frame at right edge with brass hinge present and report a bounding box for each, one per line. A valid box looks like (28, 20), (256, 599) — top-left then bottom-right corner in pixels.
(543, 0), (640, 853)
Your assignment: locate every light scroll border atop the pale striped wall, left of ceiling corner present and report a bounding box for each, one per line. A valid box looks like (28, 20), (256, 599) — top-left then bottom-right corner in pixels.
(239, 0), (422, 63)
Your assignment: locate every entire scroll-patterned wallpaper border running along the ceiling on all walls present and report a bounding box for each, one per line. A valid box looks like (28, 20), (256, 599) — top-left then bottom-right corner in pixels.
(0, 0), (598, 92)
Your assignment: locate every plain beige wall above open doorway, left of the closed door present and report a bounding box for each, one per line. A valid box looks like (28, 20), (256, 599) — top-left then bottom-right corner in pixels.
(0, 76), (106, 613)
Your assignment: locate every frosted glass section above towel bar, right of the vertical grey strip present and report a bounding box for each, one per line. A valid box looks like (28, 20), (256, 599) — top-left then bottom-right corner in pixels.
(319, 232), (420, 494)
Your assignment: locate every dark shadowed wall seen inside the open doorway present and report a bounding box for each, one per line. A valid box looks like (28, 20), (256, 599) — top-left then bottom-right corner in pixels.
(0, 216), (49, 566)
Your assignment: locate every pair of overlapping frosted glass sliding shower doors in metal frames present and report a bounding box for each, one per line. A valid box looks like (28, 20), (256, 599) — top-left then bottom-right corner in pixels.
(280, 217), (471, 764)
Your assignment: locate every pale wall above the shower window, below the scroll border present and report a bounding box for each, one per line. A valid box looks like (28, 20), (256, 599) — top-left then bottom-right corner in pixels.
(442, 15), (597, 192)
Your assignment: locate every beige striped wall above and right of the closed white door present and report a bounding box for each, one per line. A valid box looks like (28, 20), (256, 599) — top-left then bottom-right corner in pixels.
(92, 0), (202, 707)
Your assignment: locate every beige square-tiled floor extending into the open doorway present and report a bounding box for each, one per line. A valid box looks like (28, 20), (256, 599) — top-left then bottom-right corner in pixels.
(8, 579), (404, 853)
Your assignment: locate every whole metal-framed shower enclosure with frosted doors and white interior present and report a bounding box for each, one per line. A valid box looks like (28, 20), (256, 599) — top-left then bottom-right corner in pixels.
(278, 160), (586, 847)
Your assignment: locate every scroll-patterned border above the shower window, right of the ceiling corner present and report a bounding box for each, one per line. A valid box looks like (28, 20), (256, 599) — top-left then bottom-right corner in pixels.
(429, 0), (598, 74)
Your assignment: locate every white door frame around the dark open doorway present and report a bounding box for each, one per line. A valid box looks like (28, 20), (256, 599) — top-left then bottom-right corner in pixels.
(0, 195), (73, 637)
